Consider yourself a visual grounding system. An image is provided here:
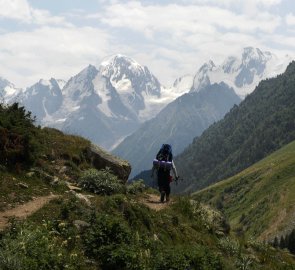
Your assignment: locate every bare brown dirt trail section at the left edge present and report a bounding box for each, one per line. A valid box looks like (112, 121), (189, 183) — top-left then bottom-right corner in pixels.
(0, 194), (58, 231)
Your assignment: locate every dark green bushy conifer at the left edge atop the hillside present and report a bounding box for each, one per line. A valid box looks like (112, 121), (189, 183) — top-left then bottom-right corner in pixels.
(0, 103), (40, 171)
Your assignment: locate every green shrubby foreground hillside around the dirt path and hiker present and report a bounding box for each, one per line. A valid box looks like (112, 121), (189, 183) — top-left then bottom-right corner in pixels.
(0, 104), (295, 270)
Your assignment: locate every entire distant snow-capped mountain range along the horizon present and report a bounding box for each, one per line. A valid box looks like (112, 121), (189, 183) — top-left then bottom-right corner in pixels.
(0, 47), (290, 150)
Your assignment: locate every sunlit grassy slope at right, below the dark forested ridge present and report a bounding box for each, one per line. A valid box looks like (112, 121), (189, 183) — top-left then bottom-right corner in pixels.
(193, 141), (295, 239)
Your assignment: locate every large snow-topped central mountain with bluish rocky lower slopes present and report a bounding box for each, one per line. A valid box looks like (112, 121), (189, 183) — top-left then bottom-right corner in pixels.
(39, 55), (163, 149)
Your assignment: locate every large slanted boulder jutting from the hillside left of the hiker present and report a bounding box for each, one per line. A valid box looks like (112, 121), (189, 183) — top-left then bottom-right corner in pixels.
(88, 144), (131, 183)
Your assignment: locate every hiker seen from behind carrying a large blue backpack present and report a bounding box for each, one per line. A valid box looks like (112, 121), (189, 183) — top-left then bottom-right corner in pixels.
(151, 144), (178, 202)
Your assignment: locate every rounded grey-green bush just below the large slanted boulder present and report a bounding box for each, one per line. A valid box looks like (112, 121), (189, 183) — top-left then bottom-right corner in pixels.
(79, 168), (125, 195)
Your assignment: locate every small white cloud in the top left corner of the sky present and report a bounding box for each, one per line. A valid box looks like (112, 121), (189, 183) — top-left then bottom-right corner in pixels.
(0, 0), (70, 26)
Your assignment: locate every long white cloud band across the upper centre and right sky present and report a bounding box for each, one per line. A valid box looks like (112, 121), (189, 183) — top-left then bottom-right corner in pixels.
(98, 1), (281, 35)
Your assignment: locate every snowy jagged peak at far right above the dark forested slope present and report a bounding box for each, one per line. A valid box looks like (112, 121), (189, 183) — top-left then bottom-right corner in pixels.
(191, 47), (291, 98)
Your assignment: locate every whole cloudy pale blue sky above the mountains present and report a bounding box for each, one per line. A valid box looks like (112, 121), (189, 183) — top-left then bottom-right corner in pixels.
(0, 0), (295, 88)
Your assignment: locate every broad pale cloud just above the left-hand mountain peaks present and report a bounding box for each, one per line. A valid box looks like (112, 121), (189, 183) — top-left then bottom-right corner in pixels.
(0, 27), (109, 87)
